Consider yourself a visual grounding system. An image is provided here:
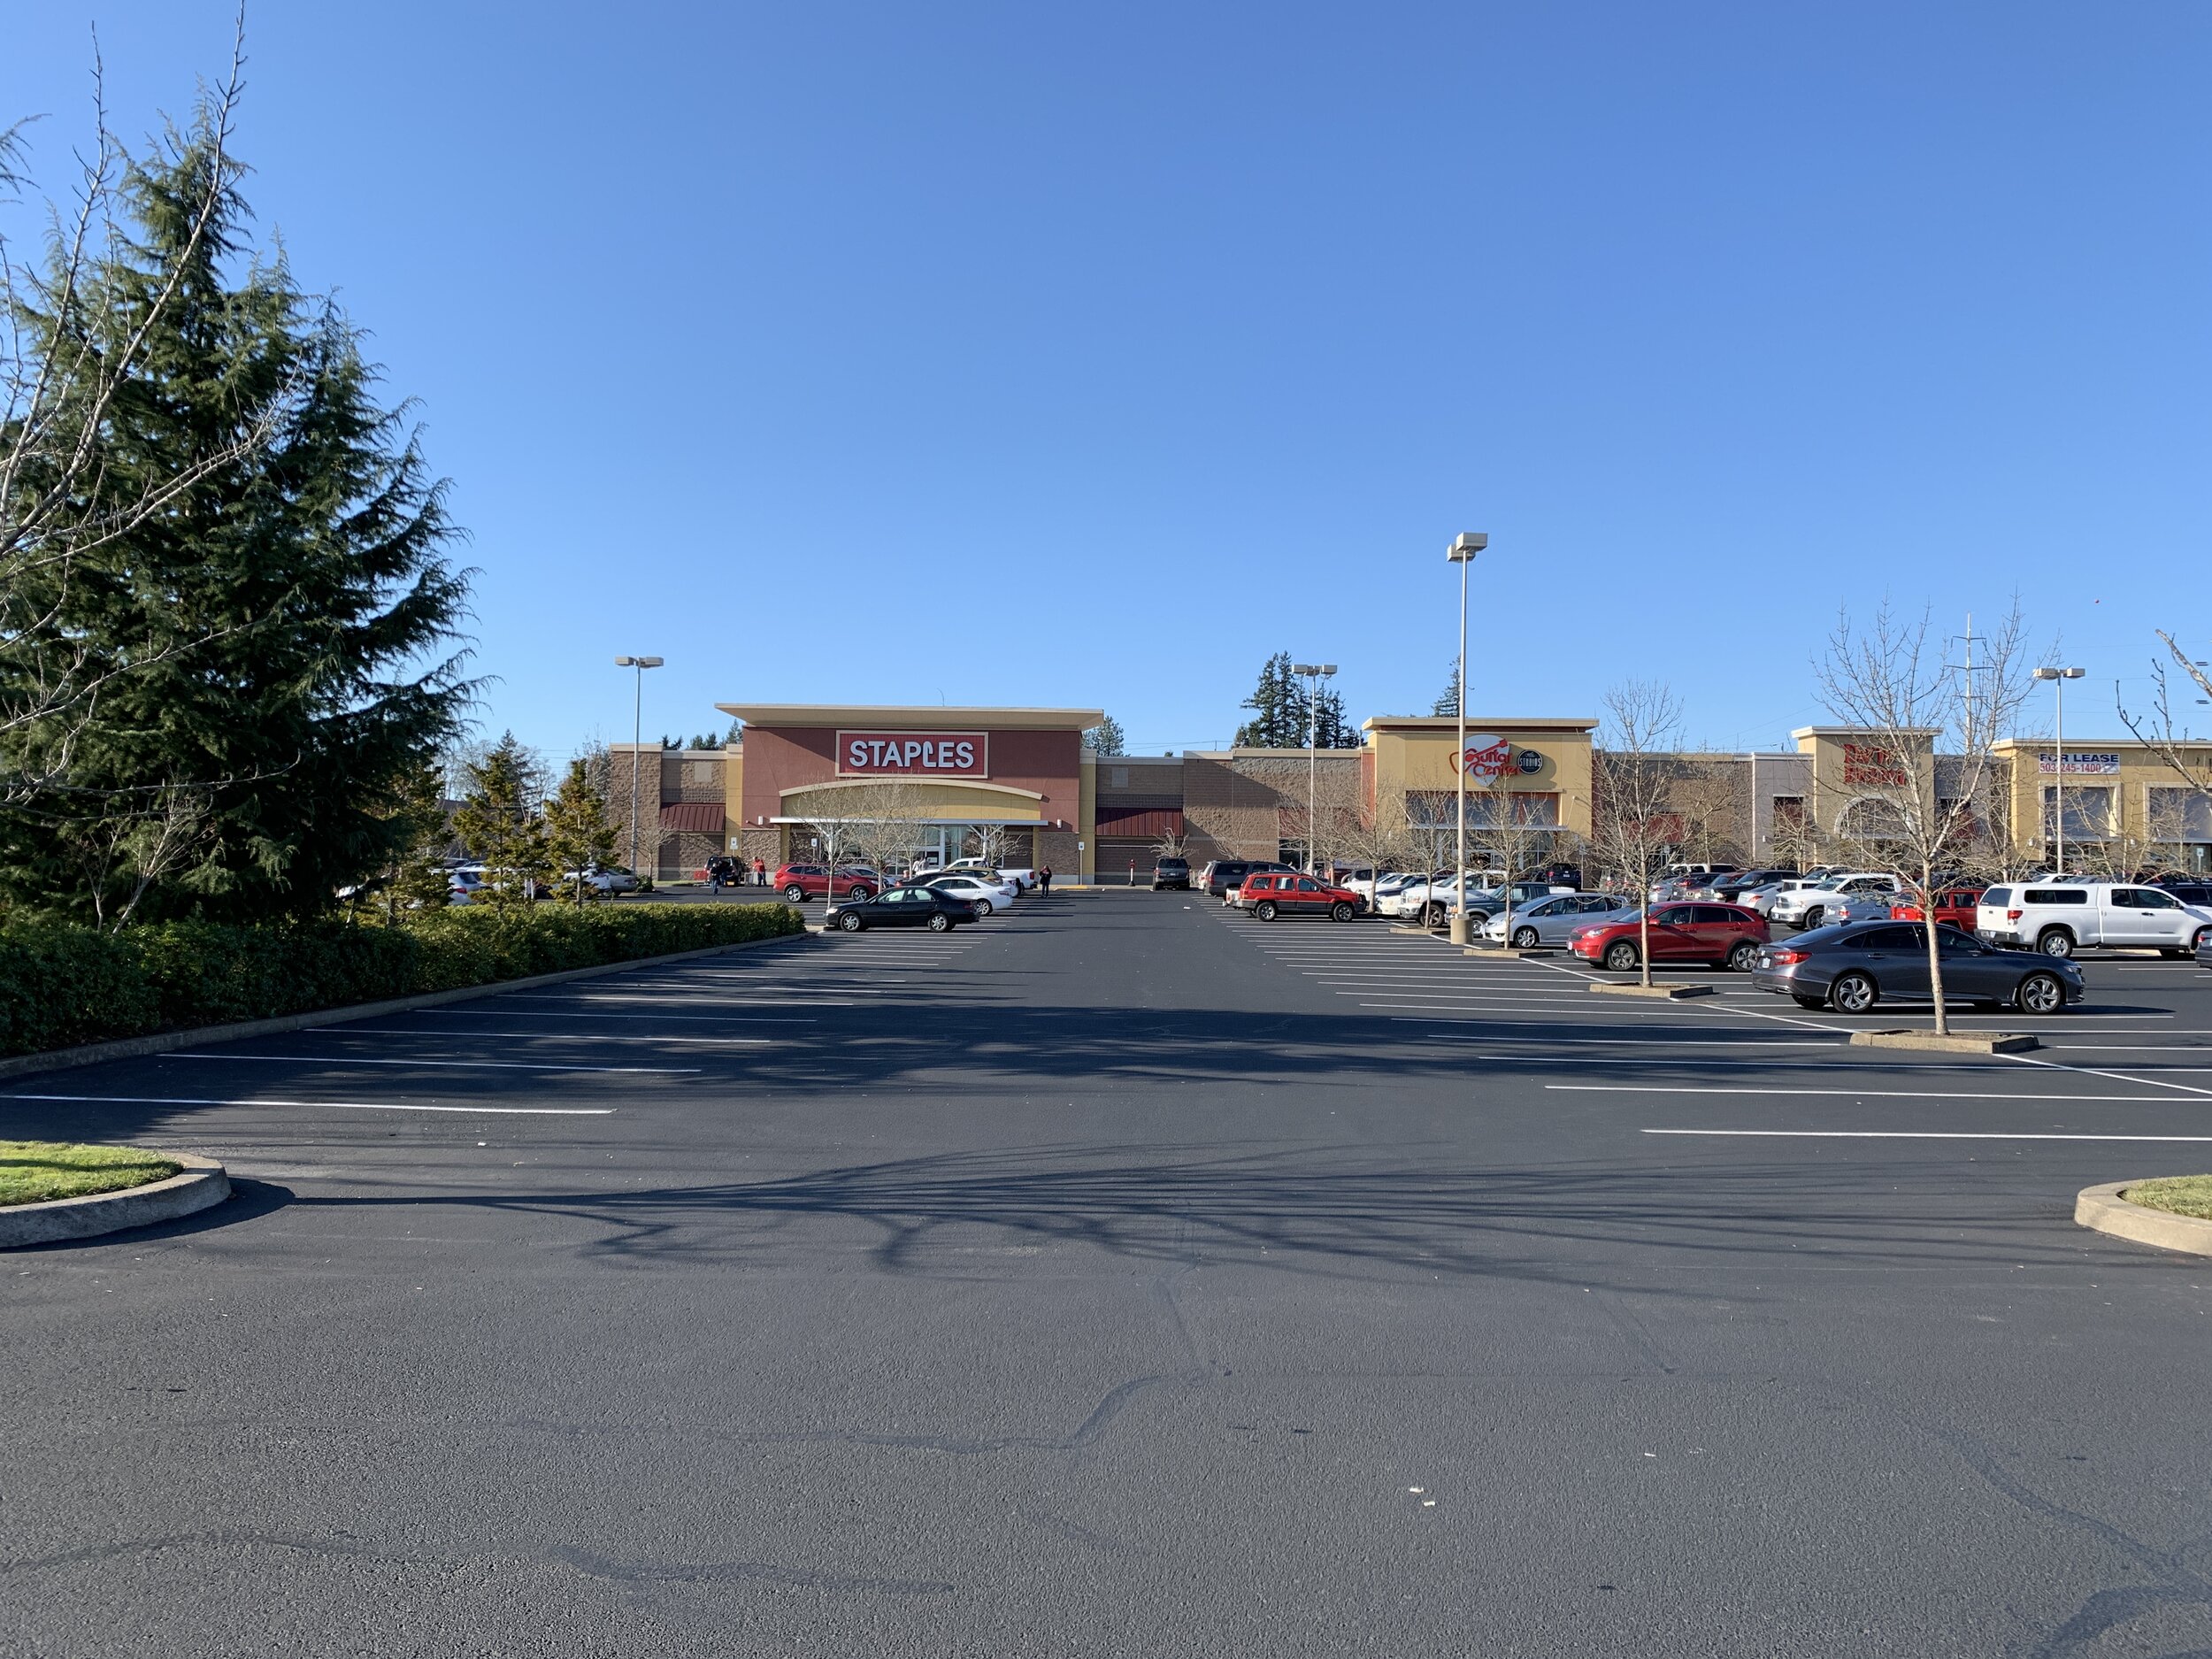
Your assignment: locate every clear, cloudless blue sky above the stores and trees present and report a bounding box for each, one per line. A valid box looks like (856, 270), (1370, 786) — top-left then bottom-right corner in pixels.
(0, 0), (2212, 755)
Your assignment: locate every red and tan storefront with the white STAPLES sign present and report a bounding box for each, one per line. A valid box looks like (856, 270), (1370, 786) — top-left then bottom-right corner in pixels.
(717, 703), (1104, 874)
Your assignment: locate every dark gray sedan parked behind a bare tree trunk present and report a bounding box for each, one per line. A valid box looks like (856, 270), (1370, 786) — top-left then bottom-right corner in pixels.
(1752, 923), (2084, 1013)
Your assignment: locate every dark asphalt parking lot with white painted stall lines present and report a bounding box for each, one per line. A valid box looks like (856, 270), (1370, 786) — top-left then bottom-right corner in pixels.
(0, 892), (2212, 1659)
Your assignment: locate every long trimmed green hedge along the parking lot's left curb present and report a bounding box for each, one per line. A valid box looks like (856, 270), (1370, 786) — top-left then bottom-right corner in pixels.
(0, 905), (805, 1056)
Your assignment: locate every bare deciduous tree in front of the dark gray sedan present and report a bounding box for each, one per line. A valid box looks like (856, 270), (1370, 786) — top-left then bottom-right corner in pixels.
(1814, 602), (2031, 1033)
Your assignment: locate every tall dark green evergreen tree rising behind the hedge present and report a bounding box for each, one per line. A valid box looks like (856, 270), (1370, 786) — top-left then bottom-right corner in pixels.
(0, 113), (472, 920)
